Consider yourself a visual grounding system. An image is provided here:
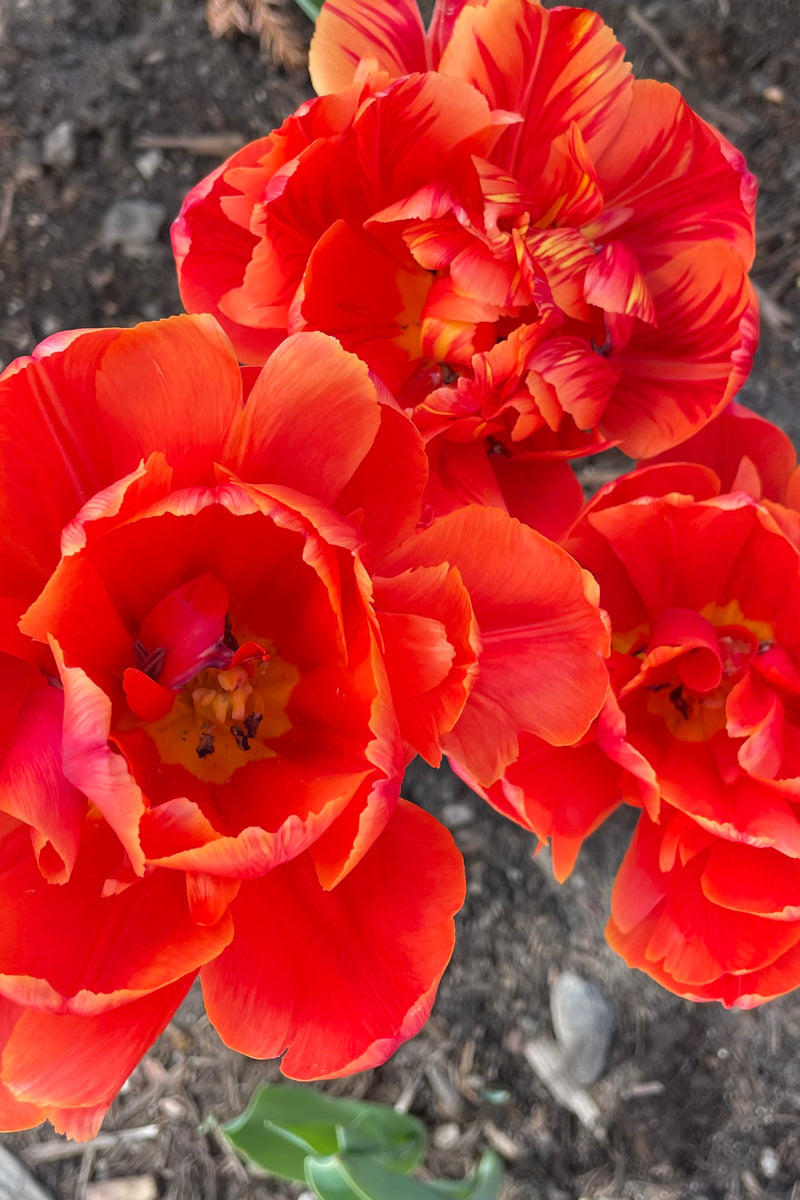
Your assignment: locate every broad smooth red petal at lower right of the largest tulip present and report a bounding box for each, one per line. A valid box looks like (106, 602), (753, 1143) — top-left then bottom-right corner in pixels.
(201, 802), (464, 1079)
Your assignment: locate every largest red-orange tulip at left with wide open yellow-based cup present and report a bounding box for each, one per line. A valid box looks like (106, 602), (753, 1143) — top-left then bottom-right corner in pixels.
(0, 317), (607, 1138)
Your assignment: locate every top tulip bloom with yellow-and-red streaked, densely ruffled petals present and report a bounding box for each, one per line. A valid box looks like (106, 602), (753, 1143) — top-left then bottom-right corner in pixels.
(174, 0), (757, 533)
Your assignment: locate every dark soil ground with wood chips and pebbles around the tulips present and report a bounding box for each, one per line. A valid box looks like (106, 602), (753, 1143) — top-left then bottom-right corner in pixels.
(0, 0), (800, 1200)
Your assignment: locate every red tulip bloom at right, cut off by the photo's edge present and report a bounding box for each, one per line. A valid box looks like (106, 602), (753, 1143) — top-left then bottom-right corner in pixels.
(488, 456), (800, 1008)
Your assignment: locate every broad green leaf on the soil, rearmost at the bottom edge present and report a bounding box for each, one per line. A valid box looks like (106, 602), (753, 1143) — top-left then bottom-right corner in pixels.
(224, 1085), (425, 1183)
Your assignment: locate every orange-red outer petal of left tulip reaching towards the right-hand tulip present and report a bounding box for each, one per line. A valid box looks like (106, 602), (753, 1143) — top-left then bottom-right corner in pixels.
(381, 506), (608, 786)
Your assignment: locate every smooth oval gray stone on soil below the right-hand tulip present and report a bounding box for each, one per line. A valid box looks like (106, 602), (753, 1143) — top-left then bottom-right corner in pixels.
(551, 971), (614, 1087)
